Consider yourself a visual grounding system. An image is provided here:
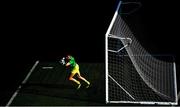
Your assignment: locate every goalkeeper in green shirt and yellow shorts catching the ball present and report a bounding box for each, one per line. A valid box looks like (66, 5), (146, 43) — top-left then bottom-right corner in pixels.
(61, 55), (90, 89)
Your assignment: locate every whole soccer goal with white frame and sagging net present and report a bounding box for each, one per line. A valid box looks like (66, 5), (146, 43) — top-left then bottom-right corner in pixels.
(105, 1), (178, 105)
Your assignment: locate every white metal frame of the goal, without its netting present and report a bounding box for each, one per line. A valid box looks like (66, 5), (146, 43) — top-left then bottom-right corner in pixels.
(105, 0), (178, 105)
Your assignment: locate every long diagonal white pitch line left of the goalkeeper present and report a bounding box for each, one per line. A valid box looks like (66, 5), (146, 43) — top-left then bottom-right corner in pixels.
(6, 61), (39, 107)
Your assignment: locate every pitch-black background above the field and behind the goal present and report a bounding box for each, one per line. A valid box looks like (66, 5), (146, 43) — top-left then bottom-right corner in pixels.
(0, 0), (179, 103)
